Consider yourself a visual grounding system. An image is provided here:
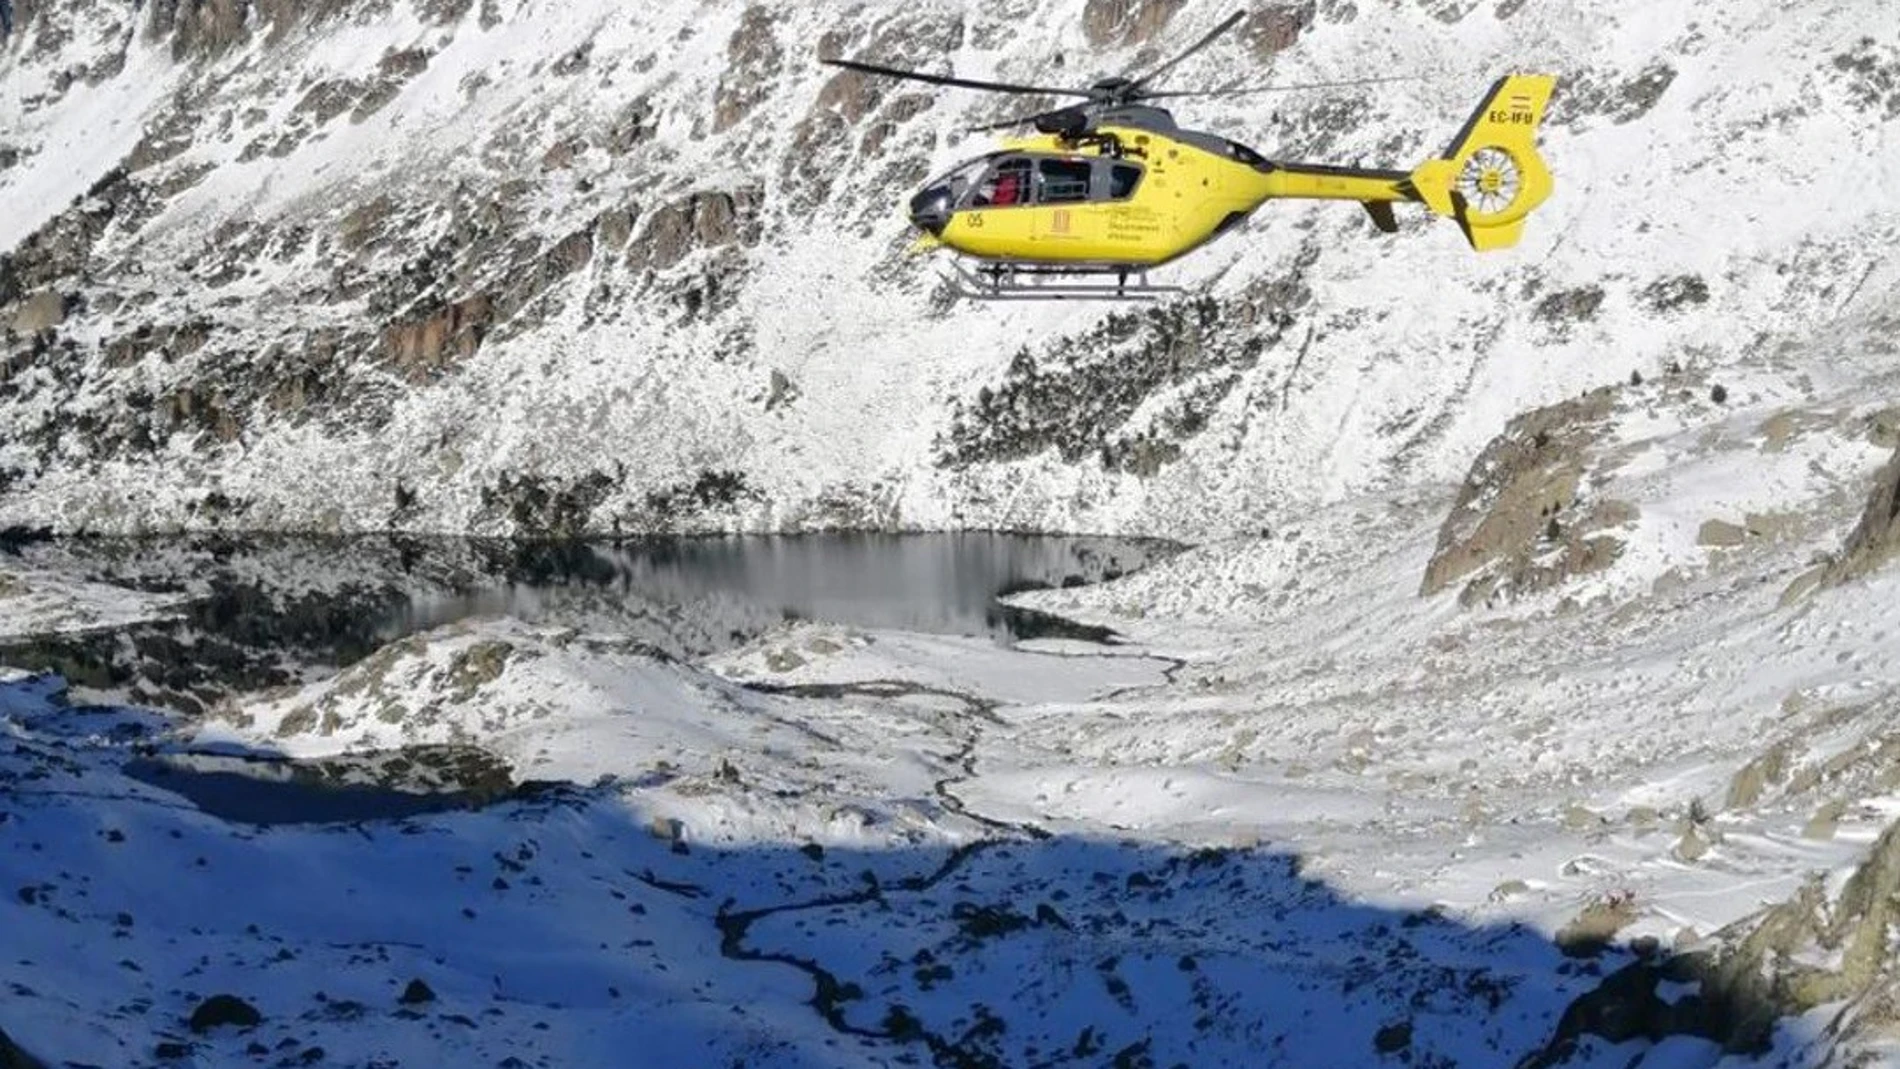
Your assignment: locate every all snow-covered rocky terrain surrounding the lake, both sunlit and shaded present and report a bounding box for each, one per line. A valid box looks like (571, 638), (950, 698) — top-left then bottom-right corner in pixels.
(0, 0), (1900, 1067)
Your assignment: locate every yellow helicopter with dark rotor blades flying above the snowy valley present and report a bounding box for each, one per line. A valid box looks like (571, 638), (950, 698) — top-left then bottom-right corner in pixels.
(821, 13), (1556, 300)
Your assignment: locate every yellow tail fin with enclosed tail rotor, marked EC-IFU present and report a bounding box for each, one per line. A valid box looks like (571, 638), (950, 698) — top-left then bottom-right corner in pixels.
(1412, 74), (1556, 251)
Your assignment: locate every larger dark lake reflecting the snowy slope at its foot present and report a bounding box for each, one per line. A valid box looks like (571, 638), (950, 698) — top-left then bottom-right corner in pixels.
(0, 534), (1174, 712)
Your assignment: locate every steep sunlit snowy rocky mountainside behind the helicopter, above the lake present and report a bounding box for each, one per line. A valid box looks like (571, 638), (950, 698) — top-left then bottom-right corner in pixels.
(0, 0), (1900, 537)
